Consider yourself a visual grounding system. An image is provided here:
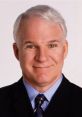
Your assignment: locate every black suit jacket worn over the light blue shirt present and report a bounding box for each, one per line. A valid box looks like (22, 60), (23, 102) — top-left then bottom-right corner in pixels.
(0, 76), (82, 117)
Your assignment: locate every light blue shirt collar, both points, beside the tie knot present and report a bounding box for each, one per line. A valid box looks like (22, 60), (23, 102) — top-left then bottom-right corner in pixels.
(23, 75), (63, 101)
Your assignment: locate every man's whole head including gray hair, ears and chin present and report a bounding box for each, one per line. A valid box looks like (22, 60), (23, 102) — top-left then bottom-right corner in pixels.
(13, 5), (68, 91)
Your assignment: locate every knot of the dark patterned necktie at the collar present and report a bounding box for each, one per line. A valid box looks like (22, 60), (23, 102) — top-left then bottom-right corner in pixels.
(35, 94), (46, 107)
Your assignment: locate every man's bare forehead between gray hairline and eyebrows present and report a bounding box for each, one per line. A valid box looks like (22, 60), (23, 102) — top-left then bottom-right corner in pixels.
(19, 17), (63, 42)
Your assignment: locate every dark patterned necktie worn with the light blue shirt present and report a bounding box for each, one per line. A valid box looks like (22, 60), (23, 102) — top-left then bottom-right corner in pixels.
(34, 94), (46, 117)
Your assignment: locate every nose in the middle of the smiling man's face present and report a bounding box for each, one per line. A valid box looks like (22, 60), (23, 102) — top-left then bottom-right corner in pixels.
(35, 48), (48, 62)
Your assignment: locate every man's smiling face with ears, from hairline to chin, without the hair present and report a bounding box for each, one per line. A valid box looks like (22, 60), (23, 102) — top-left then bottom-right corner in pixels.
(14, 17), (67, 90)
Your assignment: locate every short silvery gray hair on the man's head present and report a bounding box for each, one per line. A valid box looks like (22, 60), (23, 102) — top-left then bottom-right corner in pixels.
(13, 5), (67, 41)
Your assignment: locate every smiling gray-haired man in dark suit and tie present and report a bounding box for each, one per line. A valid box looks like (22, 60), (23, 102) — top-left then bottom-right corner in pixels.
(0, 5), (82, 117)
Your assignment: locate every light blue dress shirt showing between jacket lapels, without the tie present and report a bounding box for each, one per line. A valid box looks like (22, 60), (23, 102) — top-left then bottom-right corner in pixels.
(23, 76), (63, 110)
